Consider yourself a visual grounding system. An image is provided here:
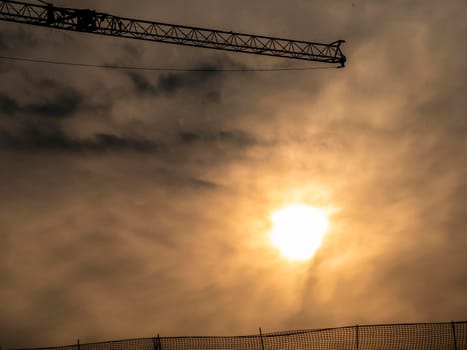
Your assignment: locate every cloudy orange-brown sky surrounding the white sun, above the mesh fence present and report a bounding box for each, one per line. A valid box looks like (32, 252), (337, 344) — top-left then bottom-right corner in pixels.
(0, 0), (467, 348)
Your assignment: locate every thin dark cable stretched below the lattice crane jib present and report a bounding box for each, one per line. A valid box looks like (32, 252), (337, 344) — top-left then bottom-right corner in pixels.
(0, 56), (341, 72)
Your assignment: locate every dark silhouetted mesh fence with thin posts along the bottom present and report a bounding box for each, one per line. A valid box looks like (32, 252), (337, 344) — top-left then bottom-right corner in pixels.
(10, 321), (467, 350)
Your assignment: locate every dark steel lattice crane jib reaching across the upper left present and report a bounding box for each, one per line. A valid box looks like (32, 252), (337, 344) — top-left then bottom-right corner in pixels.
(0, 0), (346, 67)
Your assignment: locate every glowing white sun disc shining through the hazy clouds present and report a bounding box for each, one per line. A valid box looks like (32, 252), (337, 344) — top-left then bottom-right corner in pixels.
(270, 204), (329, 260)
